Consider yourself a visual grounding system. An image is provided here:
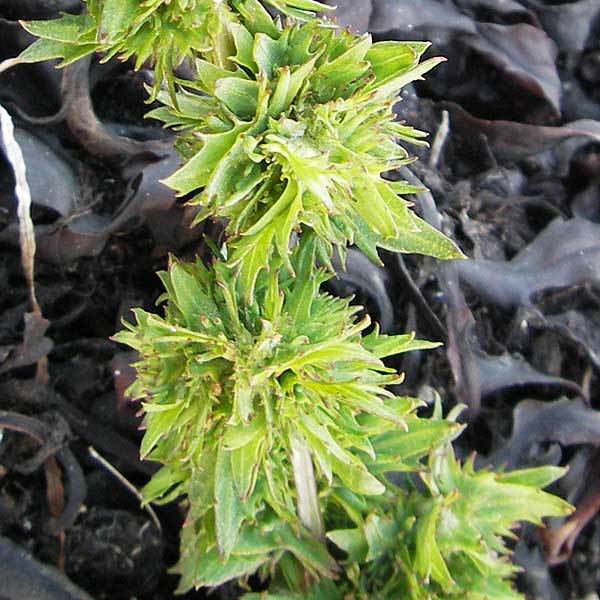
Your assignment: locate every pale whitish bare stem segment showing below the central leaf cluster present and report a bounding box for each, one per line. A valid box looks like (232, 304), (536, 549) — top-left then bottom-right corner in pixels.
(291, 435), (325, 542)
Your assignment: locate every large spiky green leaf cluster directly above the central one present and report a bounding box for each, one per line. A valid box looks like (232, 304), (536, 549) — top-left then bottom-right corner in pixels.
(149, 19), (461, 297)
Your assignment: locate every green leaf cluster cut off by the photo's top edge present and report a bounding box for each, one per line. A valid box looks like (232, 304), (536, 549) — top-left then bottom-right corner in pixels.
(21, 0), (327, 95)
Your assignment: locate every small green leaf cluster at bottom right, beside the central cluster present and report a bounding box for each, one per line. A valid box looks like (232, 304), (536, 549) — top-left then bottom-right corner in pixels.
(329, 444), (571, 600)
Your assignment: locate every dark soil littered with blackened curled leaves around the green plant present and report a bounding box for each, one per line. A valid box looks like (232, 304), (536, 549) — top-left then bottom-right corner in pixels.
(0, 0), (600, 600)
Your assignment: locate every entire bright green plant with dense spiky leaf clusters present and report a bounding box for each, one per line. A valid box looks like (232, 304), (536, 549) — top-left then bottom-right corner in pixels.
(20, 0), (569, 600)
